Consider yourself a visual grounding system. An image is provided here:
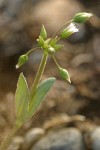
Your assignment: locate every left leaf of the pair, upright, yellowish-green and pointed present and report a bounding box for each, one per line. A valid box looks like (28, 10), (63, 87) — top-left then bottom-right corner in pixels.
(15, 73), (29, 123)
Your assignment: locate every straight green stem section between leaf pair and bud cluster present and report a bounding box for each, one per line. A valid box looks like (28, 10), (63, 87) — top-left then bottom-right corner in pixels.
(31, 52), (48, 98)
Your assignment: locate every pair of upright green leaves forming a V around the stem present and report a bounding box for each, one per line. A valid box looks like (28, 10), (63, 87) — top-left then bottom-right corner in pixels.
(15, 73), (55, 124)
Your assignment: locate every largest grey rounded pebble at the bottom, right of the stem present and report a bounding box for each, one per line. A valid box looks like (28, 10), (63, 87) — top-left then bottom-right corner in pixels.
(31, 128), (85, 150)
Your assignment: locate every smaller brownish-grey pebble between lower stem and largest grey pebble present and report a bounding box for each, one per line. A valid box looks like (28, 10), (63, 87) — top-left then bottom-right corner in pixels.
(23, 128), (45, 150)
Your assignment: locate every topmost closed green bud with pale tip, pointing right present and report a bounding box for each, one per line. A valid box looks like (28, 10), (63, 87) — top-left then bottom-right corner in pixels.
(73, 12), (93, 23)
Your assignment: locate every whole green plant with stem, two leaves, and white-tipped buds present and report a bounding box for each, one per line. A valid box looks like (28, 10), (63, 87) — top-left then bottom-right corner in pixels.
(0, 12), (92, 150)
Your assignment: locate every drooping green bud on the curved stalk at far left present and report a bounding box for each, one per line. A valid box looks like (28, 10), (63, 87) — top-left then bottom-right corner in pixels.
(16, 54), (28, 69)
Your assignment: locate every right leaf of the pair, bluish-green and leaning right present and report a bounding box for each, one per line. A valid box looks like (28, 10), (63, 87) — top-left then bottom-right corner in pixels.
(28, 77), (56, 119)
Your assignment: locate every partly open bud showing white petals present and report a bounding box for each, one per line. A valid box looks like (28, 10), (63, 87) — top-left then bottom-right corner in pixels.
(61, 23), (79, 38)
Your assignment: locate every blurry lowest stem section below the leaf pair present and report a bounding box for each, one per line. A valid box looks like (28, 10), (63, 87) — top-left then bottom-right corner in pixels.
(0, 127), (19, 150)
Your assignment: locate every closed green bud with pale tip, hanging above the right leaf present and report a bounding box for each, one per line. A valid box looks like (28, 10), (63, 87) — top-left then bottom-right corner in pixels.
(59, 68), (71, 83)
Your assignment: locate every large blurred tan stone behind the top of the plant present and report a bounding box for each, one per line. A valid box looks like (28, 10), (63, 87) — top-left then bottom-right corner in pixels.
(31, 0), (83, 33)
